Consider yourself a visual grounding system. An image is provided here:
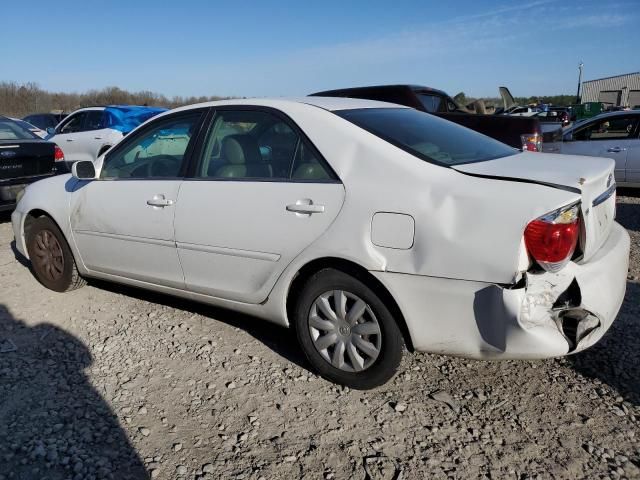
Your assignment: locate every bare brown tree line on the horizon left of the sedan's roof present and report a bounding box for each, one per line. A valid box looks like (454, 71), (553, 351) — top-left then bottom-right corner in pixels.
(0, 81), (228, 118)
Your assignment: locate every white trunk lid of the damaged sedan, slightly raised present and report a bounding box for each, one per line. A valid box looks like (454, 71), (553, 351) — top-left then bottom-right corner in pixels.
(452, 152), (616, 261)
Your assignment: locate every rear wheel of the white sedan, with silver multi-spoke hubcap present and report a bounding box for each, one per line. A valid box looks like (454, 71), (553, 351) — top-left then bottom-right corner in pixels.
(293, 268), (404, 390)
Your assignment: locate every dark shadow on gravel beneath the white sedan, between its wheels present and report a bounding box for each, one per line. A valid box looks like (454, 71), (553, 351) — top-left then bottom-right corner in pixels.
(89, 279), (311, 370)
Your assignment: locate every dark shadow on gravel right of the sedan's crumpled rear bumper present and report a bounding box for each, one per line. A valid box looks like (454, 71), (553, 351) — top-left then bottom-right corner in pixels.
(567, 283), (640, 406)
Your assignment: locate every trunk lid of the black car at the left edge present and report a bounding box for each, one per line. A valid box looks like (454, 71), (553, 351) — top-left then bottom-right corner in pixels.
(0, 139), (55, 182)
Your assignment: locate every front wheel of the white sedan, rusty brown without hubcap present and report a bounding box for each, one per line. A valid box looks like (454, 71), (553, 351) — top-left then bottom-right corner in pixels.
(25, 217), (86, 292)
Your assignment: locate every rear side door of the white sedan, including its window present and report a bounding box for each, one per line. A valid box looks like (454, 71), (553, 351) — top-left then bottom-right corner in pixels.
(175, 108), (344, 303)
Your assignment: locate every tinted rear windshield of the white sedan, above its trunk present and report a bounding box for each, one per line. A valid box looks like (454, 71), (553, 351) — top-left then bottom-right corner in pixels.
(335, 108), (518, 166)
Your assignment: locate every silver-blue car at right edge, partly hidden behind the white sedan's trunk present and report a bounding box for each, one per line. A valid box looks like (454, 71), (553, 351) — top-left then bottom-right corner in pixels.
(558, 110), (640, 187)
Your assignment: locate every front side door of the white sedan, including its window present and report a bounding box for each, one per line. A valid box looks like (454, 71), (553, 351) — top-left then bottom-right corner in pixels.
(70, 110), (204, 288)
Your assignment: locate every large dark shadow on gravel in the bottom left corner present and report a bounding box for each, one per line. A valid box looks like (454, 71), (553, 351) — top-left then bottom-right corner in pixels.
(0, 304), (147, 480)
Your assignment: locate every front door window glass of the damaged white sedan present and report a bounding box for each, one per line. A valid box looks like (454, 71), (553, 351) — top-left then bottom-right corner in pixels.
(100, 112), (200, 179)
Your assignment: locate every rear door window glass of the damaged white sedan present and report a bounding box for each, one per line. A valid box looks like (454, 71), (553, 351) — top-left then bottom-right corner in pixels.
(196, 110), (333, 180)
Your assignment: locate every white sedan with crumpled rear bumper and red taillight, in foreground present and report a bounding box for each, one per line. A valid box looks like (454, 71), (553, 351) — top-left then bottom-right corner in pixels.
(12, 97), (629, 388)
